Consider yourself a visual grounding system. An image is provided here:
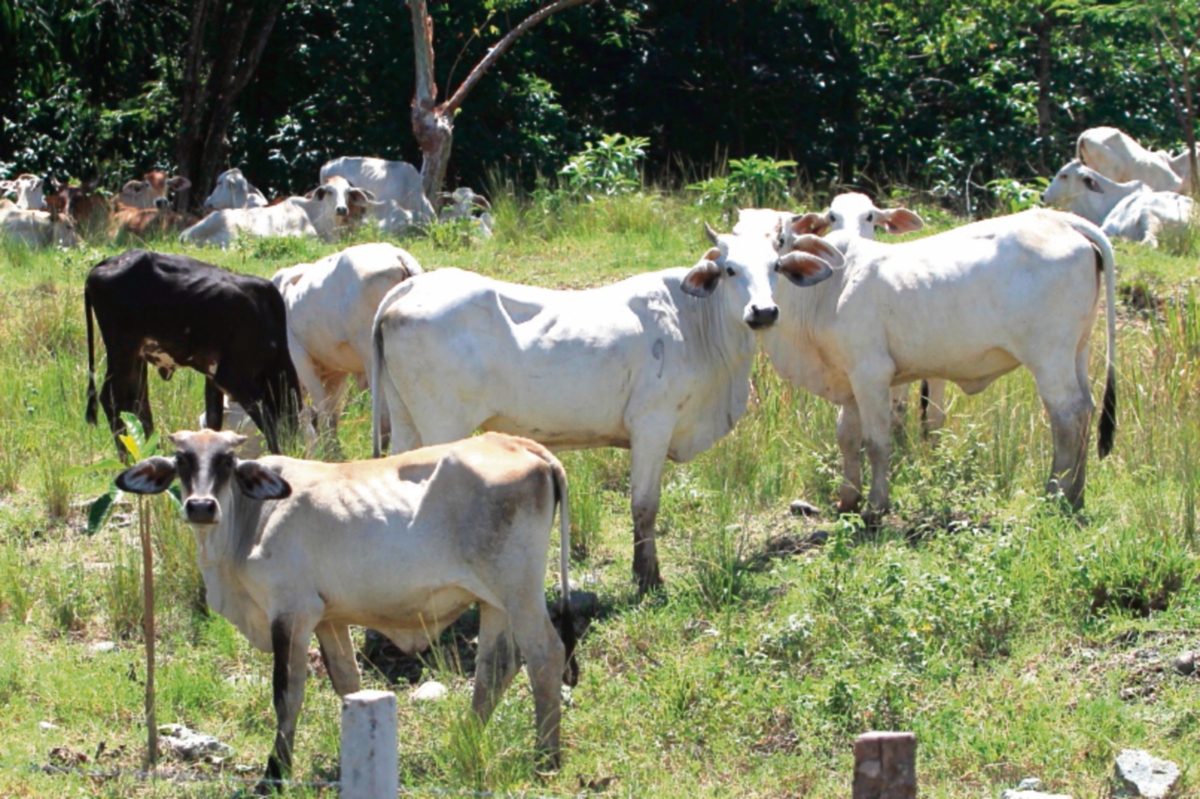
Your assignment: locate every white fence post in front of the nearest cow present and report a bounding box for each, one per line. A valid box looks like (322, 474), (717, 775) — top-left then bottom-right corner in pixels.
(341, 691), (400, 799)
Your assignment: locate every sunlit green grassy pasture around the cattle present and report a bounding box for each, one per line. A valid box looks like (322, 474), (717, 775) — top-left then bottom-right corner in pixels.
(0, 196), (1200, 799)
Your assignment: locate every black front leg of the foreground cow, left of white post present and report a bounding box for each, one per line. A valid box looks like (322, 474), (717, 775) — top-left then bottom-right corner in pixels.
(260, 614), (316, 787)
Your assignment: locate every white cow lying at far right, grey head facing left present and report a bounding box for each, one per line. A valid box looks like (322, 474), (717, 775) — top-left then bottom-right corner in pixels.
(1042, 158), (1194, 247)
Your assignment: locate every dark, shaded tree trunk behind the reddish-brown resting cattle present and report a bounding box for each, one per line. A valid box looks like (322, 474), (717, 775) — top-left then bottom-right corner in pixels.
(175, 0), (286, 211)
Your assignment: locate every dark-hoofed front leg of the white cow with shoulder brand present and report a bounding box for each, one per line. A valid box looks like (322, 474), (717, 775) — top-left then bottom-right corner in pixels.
(629, 419), (674, 594)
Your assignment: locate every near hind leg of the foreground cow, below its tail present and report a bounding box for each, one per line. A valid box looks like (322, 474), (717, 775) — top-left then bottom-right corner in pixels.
(512, 597), (566, 770)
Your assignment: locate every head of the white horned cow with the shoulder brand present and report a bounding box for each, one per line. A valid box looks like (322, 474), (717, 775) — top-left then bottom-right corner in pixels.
(680, 219), (842, 330)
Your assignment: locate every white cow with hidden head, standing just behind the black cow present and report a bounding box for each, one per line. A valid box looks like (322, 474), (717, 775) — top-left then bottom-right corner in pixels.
(271, 244), (422, 441)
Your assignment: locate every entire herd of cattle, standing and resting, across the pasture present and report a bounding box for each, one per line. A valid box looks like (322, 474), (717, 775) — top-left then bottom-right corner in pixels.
(0, 122), (1190, 777)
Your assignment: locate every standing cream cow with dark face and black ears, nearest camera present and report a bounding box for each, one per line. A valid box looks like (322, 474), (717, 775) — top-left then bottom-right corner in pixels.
(116, 431), (577, 780)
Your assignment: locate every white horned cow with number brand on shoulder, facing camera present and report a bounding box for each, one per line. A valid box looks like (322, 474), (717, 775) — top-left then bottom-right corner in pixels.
(371, 229), (841, 590)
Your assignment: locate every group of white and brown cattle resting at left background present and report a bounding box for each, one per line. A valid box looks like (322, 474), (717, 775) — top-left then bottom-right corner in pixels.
(0, 157), (492, 247)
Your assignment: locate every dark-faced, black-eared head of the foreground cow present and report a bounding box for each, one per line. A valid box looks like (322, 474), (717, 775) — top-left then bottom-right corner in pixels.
(116, 429), (292, 527)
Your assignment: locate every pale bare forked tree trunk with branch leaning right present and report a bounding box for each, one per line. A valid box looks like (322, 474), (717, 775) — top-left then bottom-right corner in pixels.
(407, 0), (595, 202)
